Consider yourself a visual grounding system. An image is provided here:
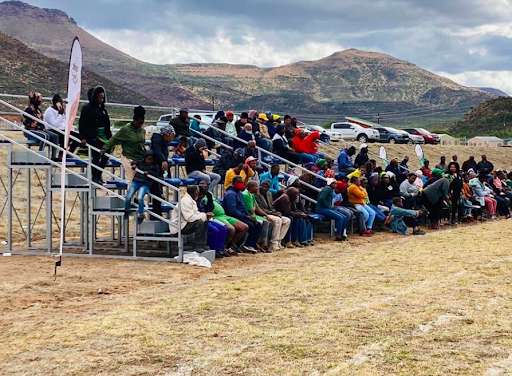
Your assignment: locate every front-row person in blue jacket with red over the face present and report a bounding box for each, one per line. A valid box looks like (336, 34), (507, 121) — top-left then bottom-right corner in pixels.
(222, 176), (262, 253)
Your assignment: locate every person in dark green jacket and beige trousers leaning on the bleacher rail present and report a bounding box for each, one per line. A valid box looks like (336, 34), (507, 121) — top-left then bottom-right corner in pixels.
(101, 106), (146, 181)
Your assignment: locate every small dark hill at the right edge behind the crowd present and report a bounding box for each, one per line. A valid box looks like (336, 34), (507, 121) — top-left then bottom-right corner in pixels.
(450, 97), (512, 137)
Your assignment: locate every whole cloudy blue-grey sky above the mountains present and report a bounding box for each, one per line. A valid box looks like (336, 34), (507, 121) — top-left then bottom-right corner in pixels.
(28, 0), (512, 94)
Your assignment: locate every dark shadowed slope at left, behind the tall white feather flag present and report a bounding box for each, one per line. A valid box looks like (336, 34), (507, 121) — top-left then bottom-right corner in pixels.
(0, 28), (152, 104)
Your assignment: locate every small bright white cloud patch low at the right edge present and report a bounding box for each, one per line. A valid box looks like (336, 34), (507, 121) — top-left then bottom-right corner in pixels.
(437, 71), (512, 95)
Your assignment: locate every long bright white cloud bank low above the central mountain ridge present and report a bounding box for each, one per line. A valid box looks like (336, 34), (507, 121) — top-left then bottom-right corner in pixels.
(87, 30), (344, 67)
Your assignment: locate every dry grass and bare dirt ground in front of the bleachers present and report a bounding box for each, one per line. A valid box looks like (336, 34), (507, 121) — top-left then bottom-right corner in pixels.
(0, 220), (512, 376)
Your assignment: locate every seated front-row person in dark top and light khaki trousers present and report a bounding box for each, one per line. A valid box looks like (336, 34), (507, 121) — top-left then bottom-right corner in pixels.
(255, 180), (292, 251)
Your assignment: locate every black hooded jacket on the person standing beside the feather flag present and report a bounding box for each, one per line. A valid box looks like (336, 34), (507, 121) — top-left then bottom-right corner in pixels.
(78, 86), (111, 144)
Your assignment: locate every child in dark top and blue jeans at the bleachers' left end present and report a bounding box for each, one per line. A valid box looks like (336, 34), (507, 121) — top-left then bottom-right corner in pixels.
(124, 150), (160, 224)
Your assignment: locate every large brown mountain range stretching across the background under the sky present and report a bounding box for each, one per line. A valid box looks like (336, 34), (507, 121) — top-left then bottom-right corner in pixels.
(0, 1), (495, 118)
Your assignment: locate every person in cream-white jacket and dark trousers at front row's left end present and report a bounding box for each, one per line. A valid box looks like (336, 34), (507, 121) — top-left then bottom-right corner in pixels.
(169, 185), (213, 253)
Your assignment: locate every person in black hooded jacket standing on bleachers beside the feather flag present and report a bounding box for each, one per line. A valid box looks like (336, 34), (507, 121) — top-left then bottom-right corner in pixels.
(78, 86), (111, 185)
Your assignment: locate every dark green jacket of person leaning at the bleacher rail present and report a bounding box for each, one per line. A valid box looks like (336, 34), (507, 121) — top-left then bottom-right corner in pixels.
(103, 123), (146, 161)
